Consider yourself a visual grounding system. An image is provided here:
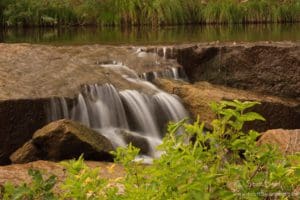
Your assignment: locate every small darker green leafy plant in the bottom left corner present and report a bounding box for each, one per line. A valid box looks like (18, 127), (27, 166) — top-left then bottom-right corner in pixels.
(0, 169), (56, 200)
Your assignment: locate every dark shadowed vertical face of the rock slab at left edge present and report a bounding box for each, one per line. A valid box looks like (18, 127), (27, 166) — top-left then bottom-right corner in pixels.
(0, 99), (49, 165)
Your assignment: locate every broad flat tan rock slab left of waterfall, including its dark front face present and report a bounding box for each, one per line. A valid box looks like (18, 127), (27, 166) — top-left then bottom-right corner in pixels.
(0, 44), (173, 165)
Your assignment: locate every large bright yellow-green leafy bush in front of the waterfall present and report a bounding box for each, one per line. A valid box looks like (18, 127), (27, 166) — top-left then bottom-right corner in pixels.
(4, 101), (300, 200)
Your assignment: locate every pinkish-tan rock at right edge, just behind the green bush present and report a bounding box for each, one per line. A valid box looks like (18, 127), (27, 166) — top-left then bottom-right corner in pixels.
(258, 129), (300, 154)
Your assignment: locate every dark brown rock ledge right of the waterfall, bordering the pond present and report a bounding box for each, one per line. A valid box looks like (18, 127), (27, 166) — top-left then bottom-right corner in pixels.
(176, 42), (300, 99)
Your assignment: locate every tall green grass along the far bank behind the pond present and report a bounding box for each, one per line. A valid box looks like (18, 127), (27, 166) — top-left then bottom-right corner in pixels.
(0, 0), (300, 26)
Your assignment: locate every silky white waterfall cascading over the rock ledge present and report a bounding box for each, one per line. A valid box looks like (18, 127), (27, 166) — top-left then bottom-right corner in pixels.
(49, 48), (188, 156)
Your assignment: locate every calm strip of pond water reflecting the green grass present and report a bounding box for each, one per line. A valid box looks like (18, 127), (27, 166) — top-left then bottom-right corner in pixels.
(0, 24), (300, 44)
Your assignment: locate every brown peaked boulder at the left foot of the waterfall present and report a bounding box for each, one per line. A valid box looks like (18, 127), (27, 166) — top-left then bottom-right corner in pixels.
(10, 119), (113, 163)
